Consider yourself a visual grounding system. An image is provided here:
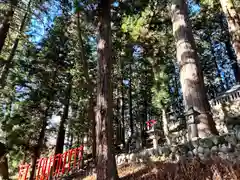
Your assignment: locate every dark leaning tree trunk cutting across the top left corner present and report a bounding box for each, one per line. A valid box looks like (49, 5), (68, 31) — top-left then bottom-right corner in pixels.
(0, 0), (18, 54)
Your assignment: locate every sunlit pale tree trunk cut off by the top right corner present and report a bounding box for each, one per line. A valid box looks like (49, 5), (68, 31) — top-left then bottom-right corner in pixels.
(220, 0), (240, 78)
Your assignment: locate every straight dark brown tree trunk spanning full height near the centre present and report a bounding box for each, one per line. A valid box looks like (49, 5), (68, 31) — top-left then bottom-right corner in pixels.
(96, 0), (119, 180)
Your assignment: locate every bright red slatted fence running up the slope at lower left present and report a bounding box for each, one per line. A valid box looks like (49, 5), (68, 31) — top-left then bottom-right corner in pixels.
(18, 146), (83, 180)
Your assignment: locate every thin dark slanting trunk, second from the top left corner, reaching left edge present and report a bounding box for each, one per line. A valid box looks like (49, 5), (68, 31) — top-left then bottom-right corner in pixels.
(0, 0), (32, 89)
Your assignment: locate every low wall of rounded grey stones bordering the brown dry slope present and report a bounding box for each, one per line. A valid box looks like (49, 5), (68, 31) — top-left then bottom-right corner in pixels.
(115, 134), (240, 164)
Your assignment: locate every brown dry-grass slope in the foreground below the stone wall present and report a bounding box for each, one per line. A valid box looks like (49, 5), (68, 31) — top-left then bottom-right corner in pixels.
(84, 157), (240, 180)
